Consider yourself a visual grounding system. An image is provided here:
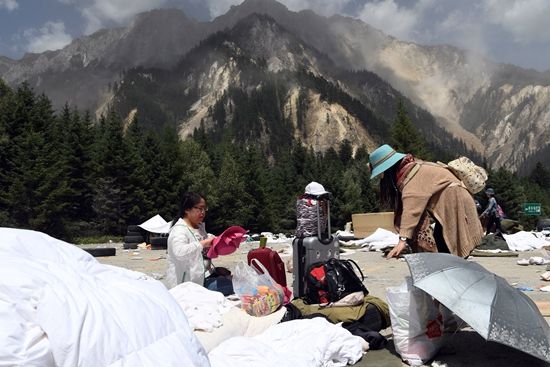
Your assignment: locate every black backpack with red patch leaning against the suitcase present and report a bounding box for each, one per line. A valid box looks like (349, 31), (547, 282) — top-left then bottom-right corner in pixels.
(304, 258), (369, 305)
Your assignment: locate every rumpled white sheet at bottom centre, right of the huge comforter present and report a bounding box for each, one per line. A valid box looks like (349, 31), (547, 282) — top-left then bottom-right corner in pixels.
(208, 317), (362, 367)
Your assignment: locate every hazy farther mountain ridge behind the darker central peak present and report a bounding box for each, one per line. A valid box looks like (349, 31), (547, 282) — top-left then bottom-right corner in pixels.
(0, 0), (550, 169)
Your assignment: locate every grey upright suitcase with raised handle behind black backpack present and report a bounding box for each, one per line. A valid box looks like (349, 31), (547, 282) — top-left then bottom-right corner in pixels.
(292, 194), (340, 298)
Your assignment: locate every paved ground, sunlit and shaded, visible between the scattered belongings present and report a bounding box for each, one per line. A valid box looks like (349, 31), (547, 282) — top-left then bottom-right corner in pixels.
(80, 240), (550, 367)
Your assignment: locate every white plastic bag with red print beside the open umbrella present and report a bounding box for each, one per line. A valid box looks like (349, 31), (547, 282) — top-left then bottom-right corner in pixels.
(386, 276), (445, 366)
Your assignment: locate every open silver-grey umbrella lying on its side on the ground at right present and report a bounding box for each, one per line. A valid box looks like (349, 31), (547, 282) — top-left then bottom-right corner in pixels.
(405, 253), (550, 362)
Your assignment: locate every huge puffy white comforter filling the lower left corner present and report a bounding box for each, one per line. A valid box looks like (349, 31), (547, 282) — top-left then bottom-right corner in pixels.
(0, 228), (210, 367)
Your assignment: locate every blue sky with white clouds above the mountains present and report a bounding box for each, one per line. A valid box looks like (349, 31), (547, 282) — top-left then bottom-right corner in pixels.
(0, 0), (550, 71)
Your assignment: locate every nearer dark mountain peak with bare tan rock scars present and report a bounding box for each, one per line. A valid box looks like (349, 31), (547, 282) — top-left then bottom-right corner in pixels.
(110, 13), (474, 160)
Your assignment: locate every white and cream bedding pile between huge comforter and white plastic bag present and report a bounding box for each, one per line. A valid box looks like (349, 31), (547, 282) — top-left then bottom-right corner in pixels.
(170, 282), (362, 367)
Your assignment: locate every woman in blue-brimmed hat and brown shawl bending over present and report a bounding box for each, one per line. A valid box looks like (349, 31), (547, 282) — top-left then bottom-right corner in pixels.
(369, 144), (483, 259)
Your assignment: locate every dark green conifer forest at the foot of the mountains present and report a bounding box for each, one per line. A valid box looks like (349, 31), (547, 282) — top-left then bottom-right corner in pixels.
(0, 80), (550, 241)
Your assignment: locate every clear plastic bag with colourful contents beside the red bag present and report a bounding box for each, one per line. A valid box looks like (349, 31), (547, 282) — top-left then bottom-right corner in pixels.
(233, 259), (284, 317)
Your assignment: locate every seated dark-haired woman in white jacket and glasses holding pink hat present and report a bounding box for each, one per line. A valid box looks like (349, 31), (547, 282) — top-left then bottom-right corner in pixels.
(166, 192), (234, 296)
